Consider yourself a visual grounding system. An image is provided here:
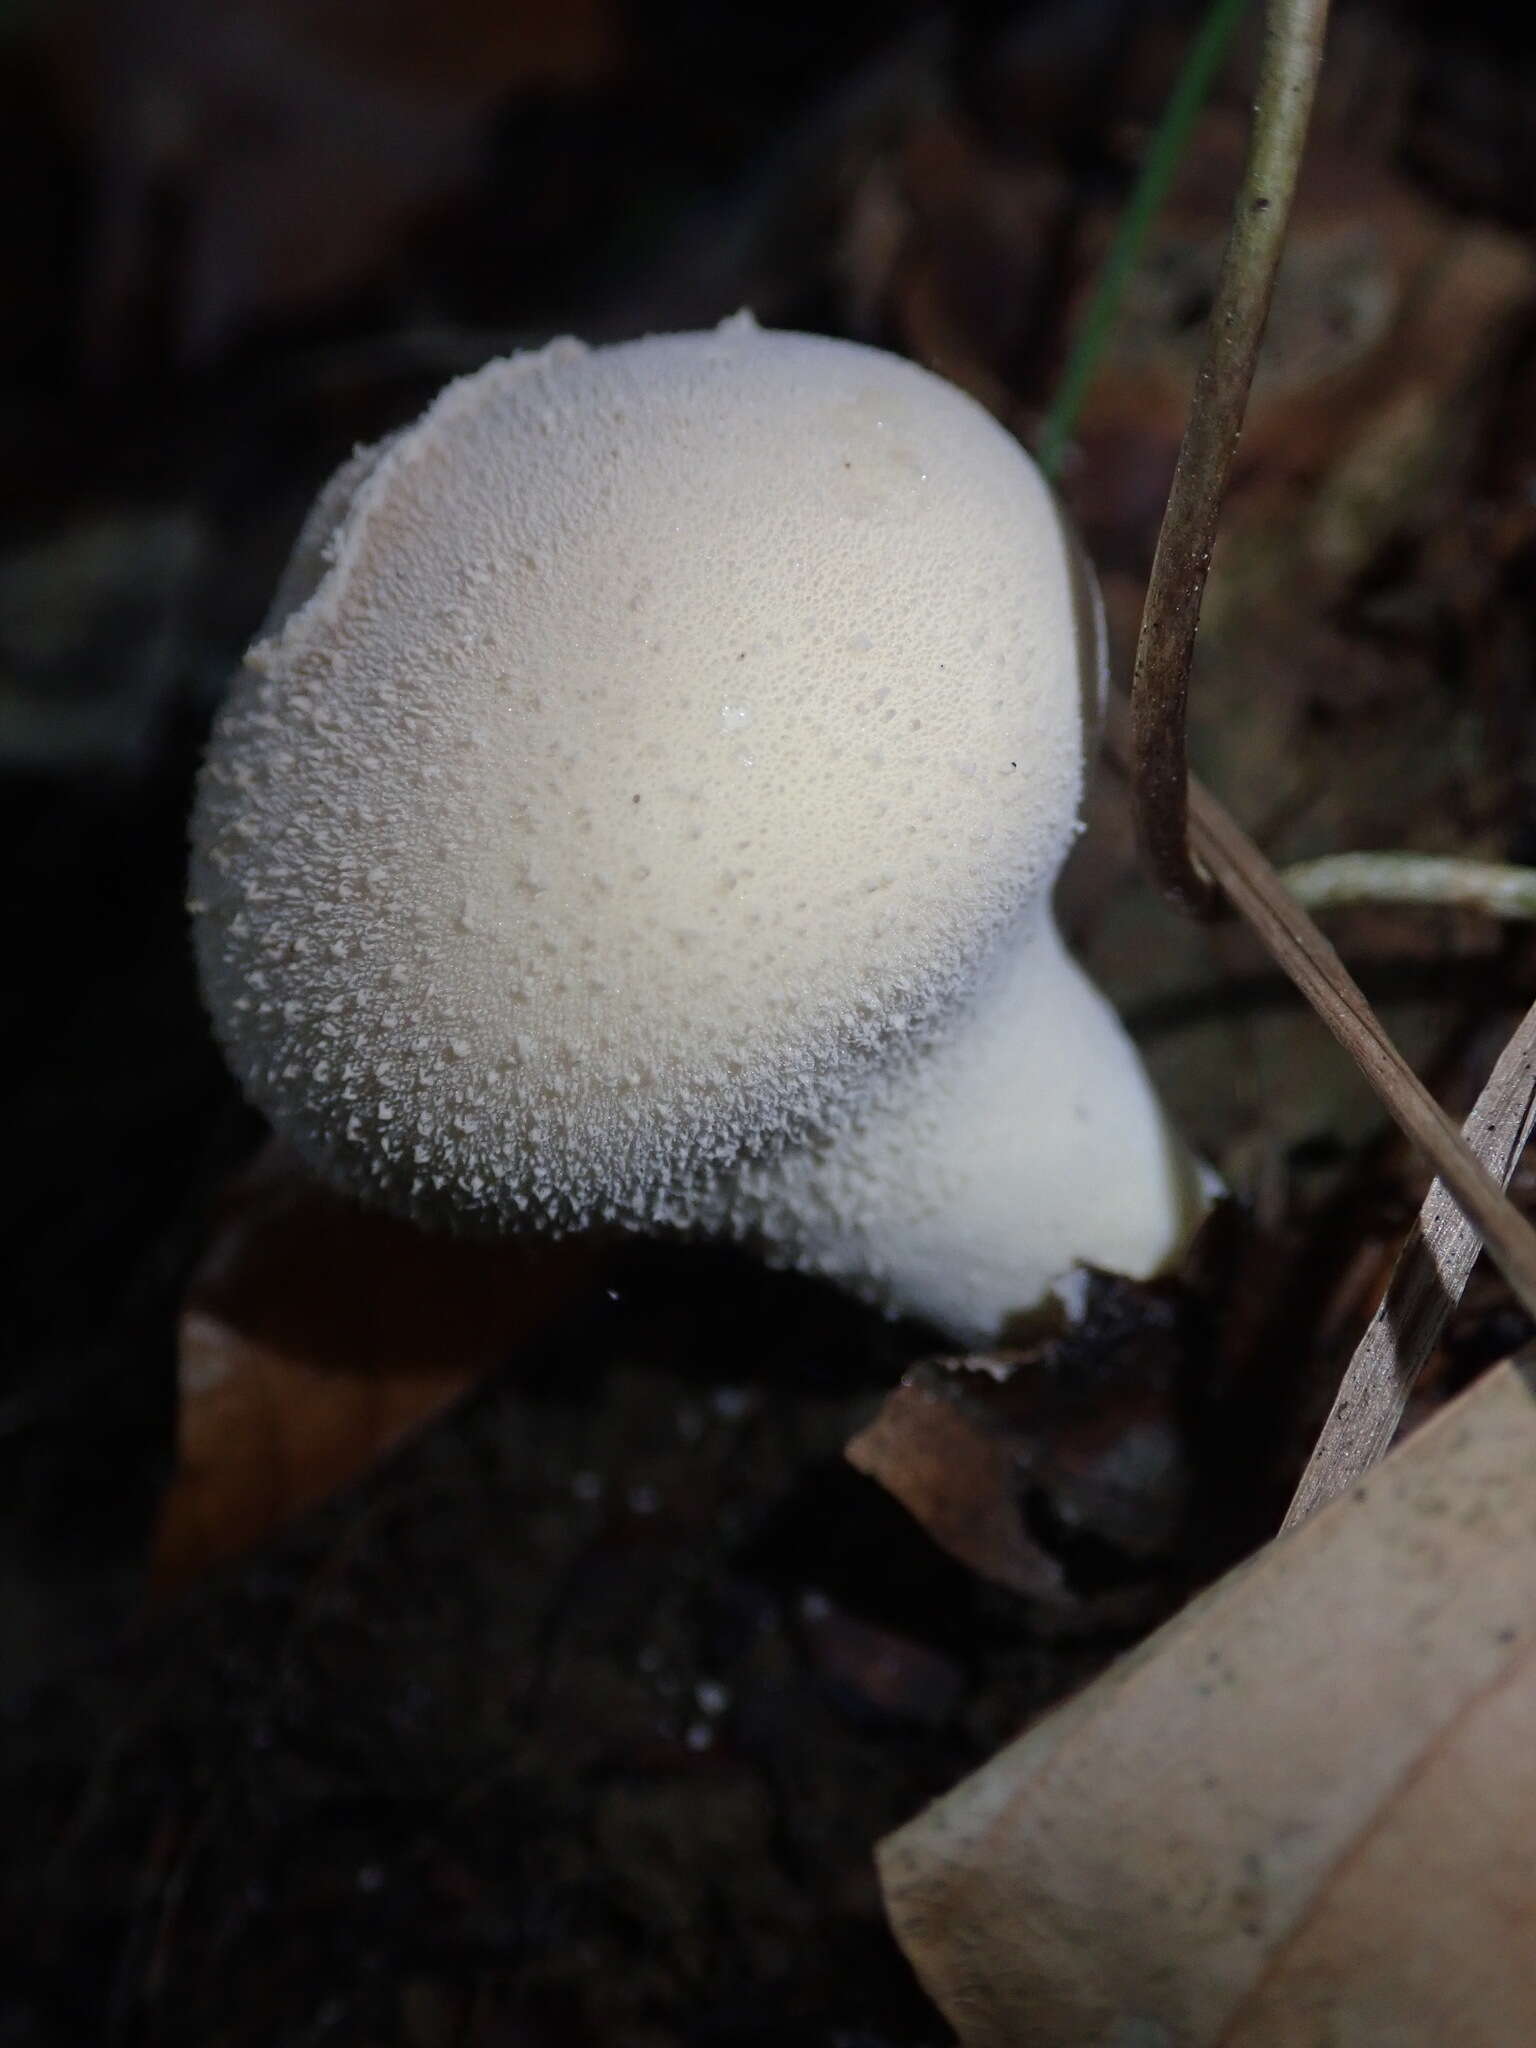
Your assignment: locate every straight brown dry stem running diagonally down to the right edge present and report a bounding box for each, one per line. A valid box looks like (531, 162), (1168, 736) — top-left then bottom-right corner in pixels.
(1190, 782), (1536, 1315)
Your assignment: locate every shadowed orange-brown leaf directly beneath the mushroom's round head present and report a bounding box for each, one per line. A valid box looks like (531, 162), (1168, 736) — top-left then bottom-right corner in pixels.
(154, 1147), (600, 1591)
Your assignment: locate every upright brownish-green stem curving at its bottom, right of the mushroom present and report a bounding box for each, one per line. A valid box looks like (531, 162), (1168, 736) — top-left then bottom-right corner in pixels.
(1130, 0), (1327, 918)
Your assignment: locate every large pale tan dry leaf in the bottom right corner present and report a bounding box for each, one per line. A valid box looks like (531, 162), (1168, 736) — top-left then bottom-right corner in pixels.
(879, 1364), (1536, 2048)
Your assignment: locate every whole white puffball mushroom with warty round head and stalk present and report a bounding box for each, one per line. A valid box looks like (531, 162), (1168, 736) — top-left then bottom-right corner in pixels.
(190, 315), (1198, 1341)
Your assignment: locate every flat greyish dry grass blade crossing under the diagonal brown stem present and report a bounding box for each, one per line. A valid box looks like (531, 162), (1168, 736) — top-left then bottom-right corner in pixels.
(1282, 1004), (1536, 1530)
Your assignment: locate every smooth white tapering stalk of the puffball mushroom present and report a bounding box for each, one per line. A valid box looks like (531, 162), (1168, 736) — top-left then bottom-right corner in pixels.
(709, 915), (1204, 1346)
